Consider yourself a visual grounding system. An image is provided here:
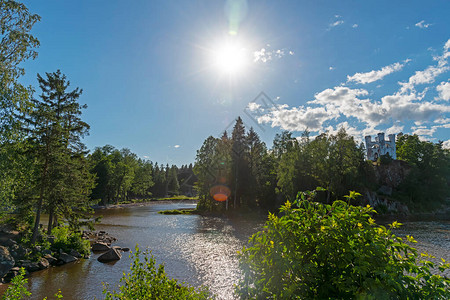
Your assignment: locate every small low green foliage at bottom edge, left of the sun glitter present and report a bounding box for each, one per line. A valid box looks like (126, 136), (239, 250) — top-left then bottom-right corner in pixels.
(103, 246), (209, 300)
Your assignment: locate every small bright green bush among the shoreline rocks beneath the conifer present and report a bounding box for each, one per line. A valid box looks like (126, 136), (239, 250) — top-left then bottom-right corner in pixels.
(52, 226), (90, 255)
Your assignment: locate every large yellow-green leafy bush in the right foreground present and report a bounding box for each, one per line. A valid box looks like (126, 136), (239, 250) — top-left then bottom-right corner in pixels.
(236, 192), (450, 299)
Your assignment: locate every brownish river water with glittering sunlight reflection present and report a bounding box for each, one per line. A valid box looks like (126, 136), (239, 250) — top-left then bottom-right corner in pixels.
(0, 202), (450, 299)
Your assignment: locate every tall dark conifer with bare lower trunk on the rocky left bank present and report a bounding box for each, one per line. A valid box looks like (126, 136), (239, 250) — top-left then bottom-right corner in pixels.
(24, 70), (93, 243)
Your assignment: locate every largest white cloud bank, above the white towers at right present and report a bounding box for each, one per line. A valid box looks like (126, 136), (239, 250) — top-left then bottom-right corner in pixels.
(254, 40), (450, 139)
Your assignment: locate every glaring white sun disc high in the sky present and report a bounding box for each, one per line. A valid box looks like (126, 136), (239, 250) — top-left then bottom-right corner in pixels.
(212, 41), (249, 75)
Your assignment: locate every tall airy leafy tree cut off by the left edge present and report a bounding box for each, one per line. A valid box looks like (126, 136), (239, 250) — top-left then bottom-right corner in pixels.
(0, 0), (40, 215)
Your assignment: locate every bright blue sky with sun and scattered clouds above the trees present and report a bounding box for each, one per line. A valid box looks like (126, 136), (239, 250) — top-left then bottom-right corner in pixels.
(22, 0), (450, 165)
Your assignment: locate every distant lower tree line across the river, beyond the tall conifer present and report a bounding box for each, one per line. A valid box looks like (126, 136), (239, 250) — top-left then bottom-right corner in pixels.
(88, 145), (195, 205)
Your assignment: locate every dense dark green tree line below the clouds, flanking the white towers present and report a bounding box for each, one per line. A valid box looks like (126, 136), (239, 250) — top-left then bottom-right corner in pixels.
(194, 117), (450, 210)
